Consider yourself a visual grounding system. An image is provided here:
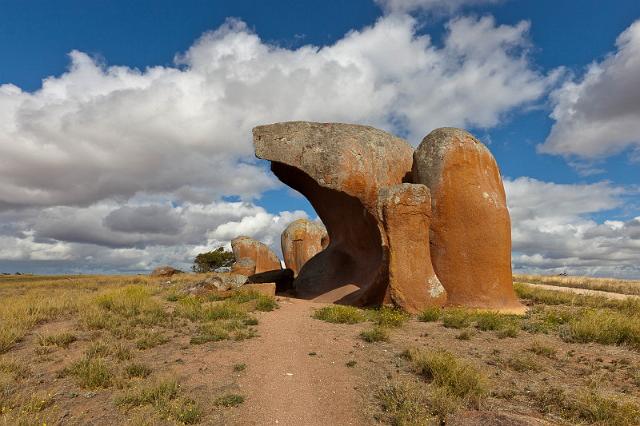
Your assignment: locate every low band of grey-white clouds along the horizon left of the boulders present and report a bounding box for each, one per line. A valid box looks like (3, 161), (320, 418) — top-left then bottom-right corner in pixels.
(0, 200), (307, 272)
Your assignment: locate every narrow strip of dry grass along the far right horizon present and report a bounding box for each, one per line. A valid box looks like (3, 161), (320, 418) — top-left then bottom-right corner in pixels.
(513, 275), (640, 295)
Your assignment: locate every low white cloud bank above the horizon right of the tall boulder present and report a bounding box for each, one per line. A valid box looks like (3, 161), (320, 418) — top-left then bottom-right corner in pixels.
(505, 177), (640, 278)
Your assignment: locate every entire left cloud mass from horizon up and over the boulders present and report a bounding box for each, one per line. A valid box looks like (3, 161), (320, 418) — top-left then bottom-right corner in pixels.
(0, 13), (554, 271)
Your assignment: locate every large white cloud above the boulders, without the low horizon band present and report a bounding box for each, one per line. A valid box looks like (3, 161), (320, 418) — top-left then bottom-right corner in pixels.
(0, 16), (548, 208)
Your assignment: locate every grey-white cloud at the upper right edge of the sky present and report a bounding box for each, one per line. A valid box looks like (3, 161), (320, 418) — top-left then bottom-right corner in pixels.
(539, 21), (640, 159)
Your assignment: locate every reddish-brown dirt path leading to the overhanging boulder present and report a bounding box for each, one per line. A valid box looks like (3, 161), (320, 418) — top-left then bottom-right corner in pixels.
(230, 299), (370, 426)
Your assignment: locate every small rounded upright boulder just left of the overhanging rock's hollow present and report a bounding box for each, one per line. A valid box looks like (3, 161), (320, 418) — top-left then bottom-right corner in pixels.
(280, 219), (329, 275)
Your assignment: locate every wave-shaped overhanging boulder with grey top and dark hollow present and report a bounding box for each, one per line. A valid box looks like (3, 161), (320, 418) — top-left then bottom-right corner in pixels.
(253, 122), (413, 305)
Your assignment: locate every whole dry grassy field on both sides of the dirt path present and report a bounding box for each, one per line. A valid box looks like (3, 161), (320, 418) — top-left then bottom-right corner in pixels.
(0, 274), (640, 425)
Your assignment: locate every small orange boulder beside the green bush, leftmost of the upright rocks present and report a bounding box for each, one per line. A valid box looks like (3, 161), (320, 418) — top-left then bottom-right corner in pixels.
(231, 237), (282, 276)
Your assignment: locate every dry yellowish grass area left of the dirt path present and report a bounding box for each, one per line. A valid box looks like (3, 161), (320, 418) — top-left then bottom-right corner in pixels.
(0, 275), (276, 425)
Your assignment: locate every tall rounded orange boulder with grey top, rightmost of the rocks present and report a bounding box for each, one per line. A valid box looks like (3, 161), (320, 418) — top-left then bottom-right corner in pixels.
(413, 128), (524, 313)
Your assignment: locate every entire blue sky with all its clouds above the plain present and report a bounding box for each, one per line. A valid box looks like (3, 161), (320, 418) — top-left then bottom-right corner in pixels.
(0, 0), (640, 278)
